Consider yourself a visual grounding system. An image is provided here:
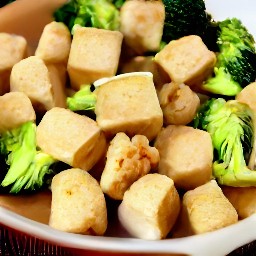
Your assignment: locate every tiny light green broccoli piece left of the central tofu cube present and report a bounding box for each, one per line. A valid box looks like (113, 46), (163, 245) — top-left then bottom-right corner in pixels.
(67, 85), (96, 111)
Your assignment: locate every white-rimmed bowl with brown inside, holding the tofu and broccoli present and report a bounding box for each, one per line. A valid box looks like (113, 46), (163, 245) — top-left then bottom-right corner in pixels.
(0, 0), (256, 256)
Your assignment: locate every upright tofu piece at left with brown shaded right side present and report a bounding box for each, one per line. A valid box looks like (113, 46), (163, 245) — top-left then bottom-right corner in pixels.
(10, 56), (66, 113)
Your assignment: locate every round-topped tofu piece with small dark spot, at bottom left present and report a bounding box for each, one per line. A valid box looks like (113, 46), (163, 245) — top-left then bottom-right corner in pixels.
(49, 168), (107, 235)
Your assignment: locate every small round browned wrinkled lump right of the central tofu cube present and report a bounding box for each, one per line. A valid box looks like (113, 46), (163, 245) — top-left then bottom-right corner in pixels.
(158, 82), (200, 125)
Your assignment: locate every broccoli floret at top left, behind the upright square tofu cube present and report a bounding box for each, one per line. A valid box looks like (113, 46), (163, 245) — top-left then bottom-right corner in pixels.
(53, 0), (122, 34)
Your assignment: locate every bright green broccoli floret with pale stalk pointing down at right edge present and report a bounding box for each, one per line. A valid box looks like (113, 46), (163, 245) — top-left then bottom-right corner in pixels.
(194, 98), (256, 187)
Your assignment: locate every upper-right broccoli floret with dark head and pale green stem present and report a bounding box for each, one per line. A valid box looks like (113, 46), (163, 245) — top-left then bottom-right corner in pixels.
(202, 18), (256, 96)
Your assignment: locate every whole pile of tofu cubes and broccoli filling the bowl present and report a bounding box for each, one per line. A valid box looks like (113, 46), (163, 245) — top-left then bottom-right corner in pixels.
(0, 0), (256, 240)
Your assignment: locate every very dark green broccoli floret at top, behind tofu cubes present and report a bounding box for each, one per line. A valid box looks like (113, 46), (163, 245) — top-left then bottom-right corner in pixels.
(163, 0), (208, 43)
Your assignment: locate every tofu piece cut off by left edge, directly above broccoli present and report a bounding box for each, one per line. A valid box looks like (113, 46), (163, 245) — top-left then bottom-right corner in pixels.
(0, 92), (36, 133)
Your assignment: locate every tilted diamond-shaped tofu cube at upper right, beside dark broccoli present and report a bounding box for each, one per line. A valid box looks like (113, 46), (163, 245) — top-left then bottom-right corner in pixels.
(155, 35), (216, 86)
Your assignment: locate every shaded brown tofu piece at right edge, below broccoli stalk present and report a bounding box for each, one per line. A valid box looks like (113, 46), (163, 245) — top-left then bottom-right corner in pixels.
(222, 186), (256, 219)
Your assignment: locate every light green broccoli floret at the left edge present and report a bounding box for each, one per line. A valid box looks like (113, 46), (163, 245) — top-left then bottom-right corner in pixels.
(0, 121), (56, 193)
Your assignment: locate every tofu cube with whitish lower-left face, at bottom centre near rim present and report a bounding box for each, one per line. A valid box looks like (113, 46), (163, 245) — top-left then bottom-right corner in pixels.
(118, 173), (180, 240)
